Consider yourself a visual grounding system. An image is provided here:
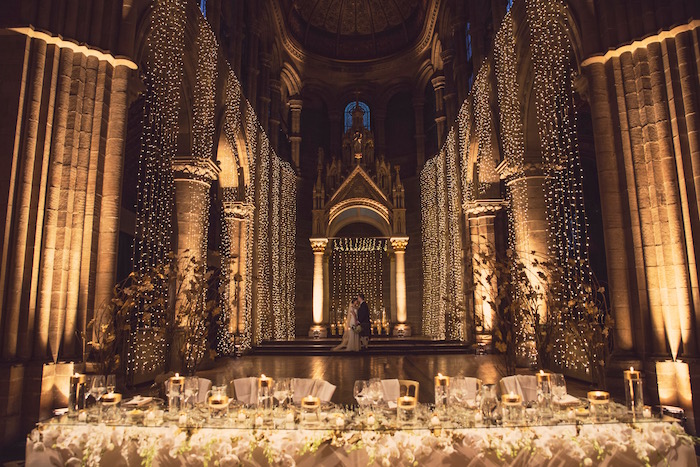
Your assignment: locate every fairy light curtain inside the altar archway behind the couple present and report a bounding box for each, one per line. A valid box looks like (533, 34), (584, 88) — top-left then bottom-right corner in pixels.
(329, 238), (388, 323)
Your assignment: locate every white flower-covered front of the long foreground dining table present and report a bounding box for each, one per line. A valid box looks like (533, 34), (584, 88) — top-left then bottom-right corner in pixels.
(26, 423), (697, 467)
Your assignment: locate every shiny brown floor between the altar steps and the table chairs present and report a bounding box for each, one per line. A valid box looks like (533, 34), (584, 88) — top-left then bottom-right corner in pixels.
(197, 353), (589, 404)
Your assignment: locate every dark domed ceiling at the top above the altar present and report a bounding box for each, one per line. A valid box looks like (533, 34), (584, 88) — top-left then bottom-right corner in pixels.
(285, 0), (429, 60)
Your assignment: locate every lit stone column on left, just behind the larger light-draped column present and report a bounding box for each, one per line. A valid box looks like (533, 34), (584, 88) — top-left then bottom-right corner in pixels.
(221, 201), (255, 334)
